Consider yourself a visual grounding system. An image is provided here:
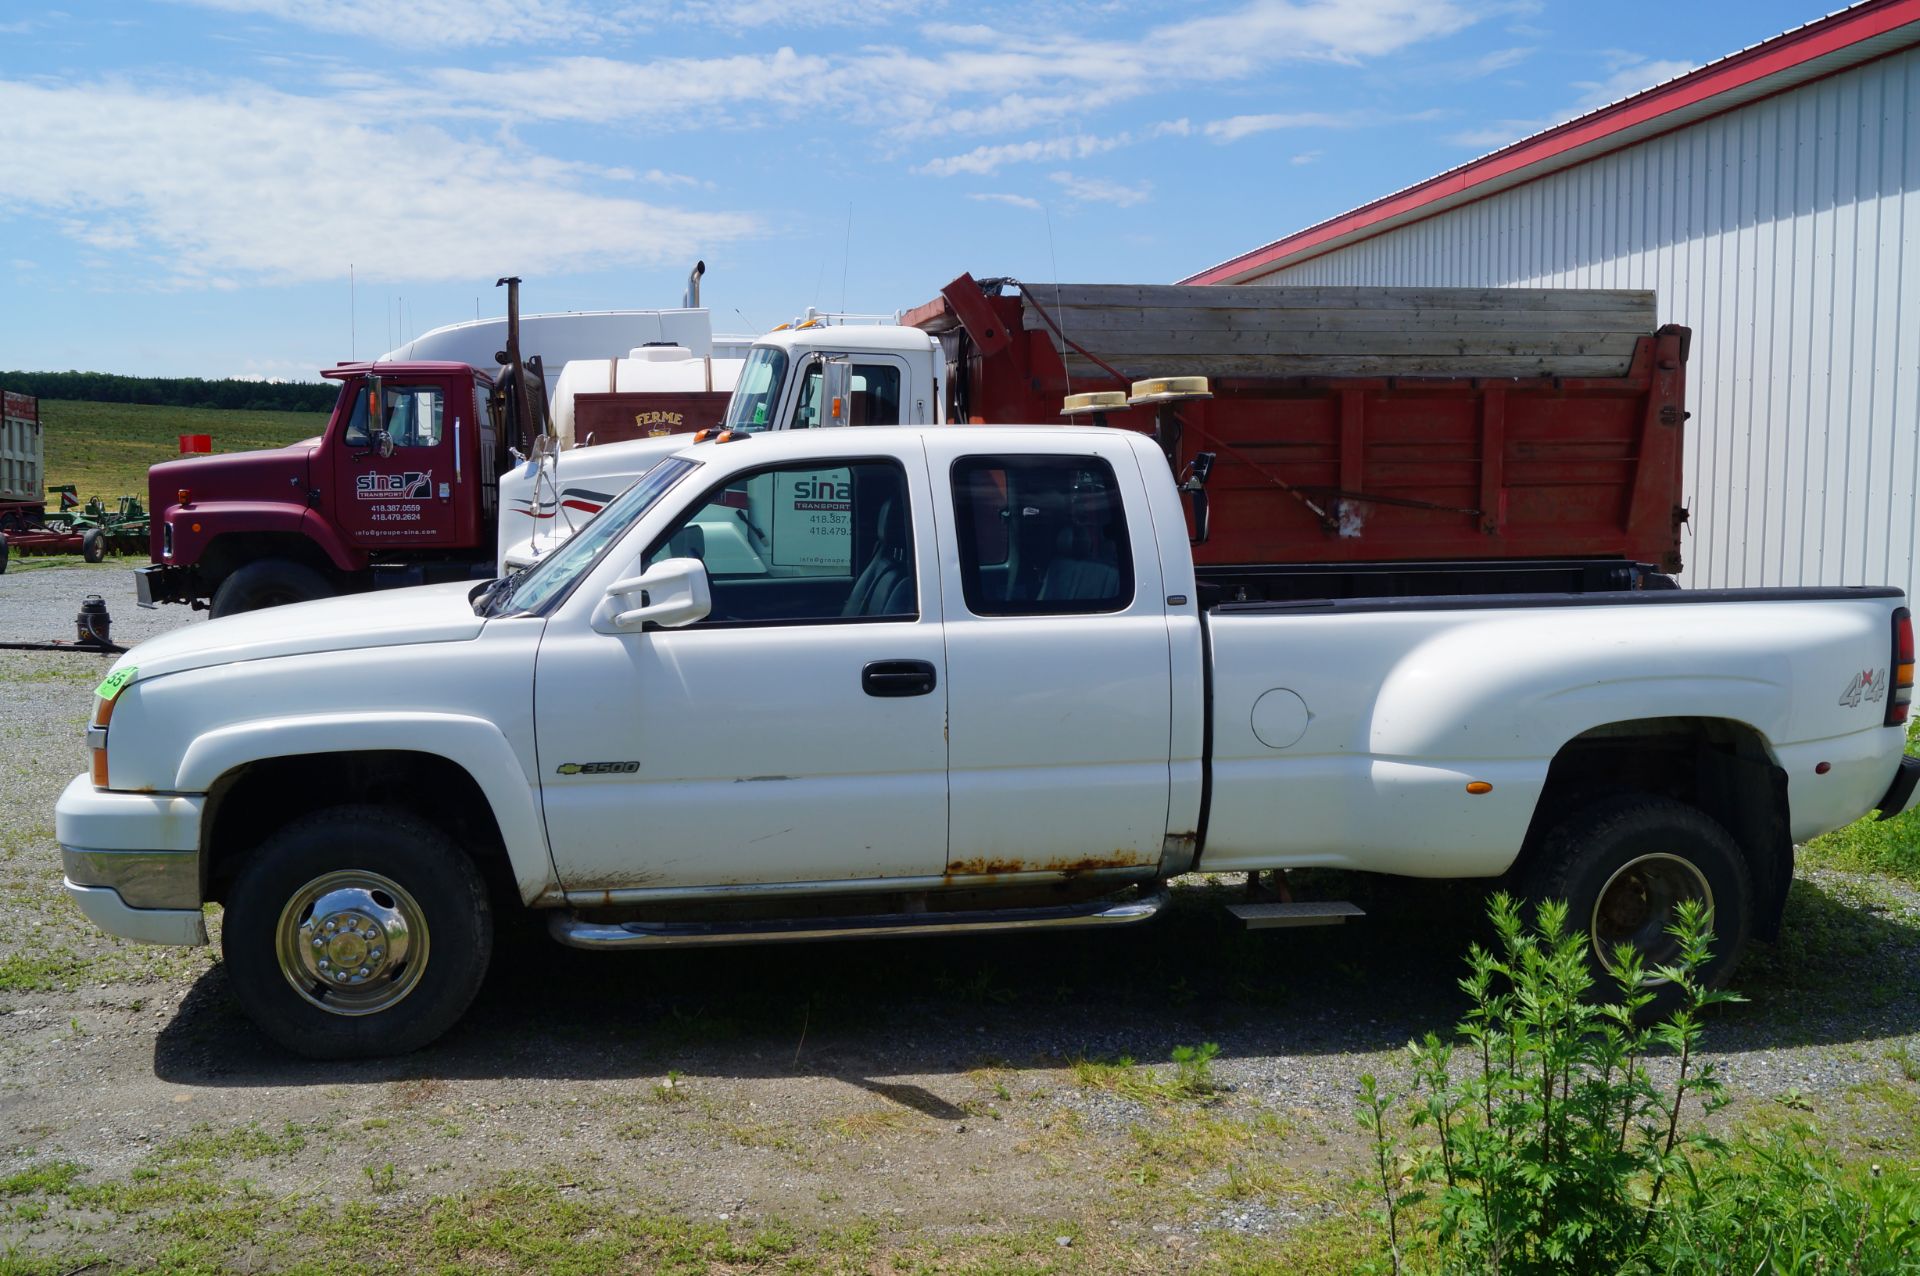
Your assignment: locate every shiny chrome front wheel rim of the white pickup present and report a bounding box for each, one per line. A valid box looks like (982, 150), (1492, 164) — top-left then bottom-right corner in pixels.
(275, 869), (426, 1015)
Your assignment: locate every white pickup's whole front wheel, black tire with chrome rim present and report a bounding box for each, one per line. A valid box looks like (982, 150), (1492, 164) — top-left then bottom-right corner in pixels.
(221, 806), (493, 1059)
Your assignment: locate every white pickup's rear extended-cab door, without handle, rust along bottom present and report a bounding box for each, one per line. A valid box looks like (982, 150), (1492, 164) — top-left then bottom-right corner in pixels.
(927, 430), (1173, 875)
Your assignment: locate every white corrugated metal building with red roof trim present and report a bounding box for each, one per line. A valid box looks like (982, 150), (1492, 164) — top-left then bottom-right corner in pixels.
(1183, 0), (1920, 597)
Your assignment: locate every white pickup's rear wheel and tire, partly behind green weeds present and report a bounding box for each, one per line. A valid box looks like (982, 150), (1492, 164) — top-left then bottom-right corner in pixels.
(1523, 794), (1753, 1015)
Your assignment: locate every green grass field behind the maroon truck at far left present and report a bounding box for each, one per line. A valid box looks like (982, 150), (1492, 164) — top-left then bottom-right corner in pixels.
(40, 399), (326, 507)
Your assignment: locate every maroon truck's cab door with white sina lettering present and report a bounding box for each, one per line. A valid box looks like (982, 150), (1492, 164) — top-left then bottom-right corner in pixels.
(328, 376), (464, 549)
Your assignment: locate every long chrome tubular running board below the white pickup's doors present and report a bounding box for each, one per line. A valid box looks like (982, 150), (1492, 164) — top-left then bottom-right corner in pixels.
(547, 890), (1167, 948)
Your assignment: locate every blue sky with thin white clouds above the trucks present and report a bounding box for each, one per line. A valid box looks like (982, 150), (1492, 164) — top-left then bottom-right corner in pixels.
(0, 0), (1822, 380)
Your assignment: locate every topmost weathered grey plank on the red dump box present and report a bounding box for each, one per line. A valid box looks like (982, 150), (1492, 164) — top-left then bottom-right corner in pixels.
(1021, 284), (1653, 316)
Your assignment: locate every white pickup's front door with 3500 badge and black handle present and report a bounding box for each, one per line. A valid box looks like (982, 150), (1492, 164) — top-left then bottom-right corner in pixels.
(536, 436), (947, 890)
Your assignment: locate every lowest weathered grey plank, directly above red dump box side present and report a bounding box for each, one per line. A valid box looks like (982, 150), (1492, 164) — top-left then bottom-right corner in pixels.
(1054, 328), (1640, 365)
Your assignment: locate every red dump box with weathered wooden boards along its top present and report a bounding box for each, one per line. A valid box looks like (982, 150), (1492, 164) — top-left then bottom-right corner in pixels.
(904, 276), (1690, 572)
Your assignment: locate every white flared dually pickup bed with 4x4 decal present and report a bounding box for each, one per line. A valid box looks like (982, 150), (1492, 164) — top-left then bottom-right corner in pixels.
(1202, 587), (1905, 877)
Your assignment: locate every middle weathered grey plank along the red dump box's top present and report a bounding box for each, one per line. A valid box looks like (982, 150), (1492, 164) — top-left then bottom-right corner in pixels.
(1021, 305), (1651, 336)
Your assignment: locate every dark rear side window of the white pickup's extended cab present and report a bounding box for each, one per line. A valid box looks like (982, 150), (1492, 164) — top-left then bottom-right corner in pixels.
(952, 455), (1135, 616)
